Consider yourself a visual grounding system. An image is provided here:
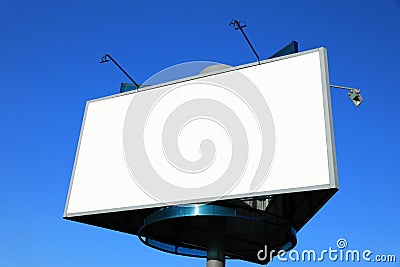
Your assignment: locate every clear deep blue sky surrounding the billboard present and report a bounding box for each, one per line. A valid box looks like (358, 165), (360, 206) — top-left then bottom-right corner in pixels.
(0, 0), (400, 267)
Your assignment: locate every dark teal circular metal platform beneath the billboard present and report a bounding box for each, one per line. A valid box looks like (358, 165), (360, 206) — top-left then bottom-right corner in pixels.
(138, 205), (297, 266)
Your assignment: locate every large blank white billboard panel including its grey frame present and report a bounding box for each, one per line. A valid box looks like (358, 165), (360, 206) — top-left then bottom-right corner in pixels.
(65, 48), (338, 217)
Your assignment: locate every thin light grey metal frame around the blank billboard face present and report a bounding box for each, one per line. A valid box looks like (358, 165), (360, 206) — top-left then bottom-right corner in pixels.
(63, 47), (339, 218)
